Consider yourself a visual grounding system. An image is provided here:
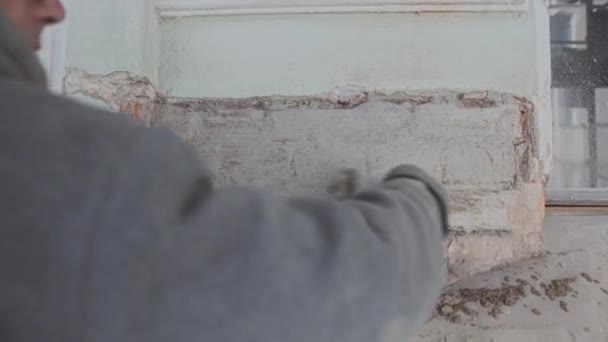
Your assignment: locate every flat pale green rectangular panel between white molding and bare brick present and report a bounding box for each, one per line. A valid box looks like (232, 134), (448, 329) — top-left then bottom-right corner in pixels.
(159, 13), (536, 97)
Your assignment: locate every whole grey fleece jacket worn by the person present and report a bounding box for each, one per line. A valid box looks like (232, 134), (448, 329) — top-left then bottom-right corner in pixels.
(0, 10), (446, 342)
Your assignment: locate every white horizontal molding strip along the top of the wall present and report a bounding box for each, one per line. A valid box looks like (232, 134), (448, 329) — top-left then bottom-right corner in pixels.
(156, 0), (528, 18)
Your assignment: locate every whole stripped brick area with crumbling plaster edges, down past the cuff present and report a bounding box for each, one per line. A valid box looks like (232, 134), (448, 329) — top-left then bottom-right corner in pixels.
(64, 69), (550, 279)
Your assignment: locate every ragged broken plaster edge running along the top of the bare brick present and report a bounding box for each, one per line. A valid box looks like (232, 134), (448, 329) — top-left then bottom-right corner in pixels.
(64, 68), (530, 137)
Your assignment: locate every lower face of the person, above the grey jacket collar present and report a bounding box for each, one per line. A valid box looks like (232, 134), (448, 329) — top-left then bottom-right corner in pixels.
(0, 0), (65, 50)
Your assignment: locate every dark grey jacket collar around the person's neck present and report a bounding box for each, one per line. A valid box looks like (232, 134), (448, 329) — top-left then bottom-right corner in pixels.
(0, 11), (46, 87)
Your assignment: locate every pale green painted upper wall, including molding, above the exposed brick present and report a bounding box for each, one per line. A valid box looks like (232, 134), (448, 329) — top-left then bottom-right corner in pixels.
(58, 0), (549, 97)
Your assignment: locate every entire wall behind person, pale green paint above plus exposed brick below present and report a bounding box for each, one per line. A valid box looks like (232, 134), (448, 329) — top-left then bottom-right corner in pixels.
(54, 0), (552, 275)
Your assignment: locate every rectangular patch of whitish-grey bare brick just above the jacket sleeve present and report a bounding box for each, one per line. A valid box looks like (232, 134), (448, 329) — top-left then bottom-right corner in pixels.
(160, 92), (532, 191)
